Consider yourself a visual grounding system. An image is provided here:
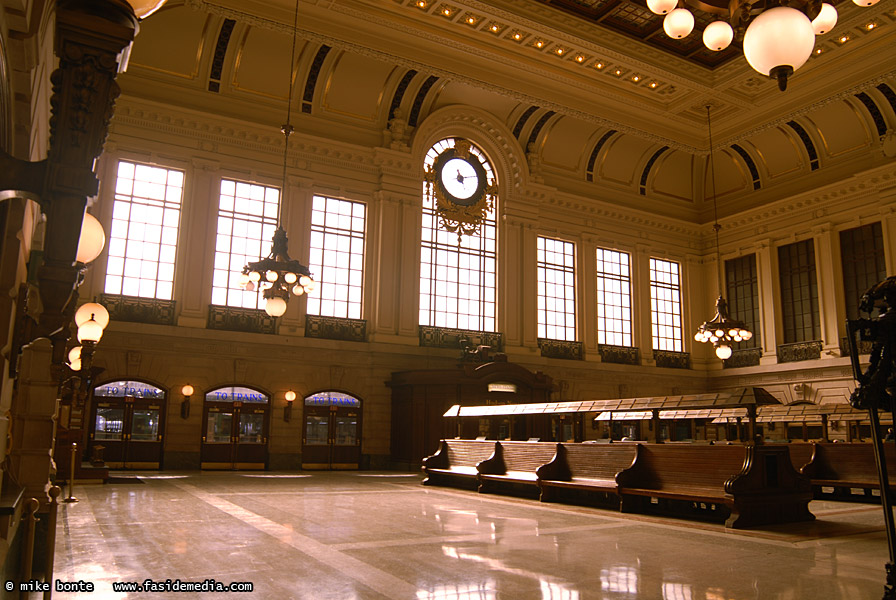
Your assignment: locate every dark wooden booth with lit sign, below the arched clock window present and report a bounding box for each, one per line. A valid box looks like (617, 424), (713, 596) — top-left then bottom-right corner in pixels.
(387, 355), (554, 469)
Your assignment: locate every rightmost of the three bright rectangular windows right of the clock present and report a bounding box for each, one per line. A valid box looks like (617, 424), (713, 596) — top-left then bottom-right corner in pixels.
(650, 258), (682, 352)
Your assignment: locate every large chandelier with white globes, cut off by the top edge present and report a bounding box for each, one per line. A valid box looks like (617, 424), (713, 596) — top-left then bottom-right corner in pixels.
(647, 0), (879, 91)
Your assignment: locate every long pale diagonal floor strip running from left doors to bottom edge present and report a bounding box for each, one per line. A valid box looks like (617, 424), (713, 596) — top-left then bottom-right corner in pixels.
(172, 484), (417, 599)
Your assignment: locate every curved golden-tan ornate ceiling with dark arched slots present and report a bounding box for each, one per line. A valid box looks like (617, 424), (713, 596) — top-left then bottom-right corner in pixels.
(120, 0), (896, 222)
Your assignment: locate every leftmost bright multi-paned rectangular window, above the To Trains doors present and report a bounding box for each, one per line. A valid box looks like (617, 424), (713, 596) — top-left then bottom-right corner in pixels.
(104, 161), (184, 300)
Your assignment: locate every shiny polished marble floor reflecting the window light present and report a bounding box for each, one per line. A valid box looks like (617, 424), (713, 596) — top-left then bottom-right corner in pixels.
(53, 471), (887, 600)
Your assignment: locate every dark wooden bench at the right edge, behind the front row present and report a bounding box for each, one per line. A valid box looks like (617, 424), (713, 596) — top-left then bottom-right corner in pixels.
(802, 442), (896, 502)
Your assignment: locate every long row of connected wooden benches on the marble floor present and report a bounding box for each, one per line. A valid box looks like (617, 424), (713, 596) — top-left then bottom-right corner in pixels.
(423, 439), (896, 528)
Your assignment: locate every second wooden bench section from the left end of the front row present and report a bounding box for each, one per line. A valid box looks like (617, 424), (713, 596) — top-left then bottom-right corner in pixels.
(479, 442), (557, 495)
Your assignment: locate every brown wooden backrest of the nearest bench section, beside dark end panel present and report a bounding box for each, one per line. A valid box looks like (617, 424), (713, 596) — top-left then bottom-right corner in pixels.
(617, 444), (747, 489)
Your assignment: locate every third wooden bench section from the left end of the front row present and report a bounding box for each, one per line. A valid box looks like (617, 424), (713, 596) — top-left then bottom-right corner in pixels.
(537, 442), (637, 506)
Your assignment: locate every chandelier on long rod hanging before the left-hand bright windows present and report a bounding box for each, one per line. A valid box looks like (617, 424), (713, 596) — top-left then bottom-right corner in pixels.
(239, 0), (315, 317)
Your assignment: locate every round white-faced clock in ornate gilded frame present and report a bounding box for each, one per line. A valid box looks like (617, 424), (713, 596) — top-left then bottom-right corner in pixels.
(425, 140), (498, 243)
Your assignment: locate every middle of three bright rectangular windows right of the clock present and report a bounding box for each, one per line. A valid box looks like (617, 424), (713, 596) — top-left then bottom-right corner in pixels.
(597, 248), (632, 346)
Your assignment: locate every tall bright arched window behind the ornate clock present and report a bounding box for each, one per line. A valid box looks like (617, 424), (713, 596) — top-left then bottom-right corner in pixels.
(420, 138), (497, 331)
